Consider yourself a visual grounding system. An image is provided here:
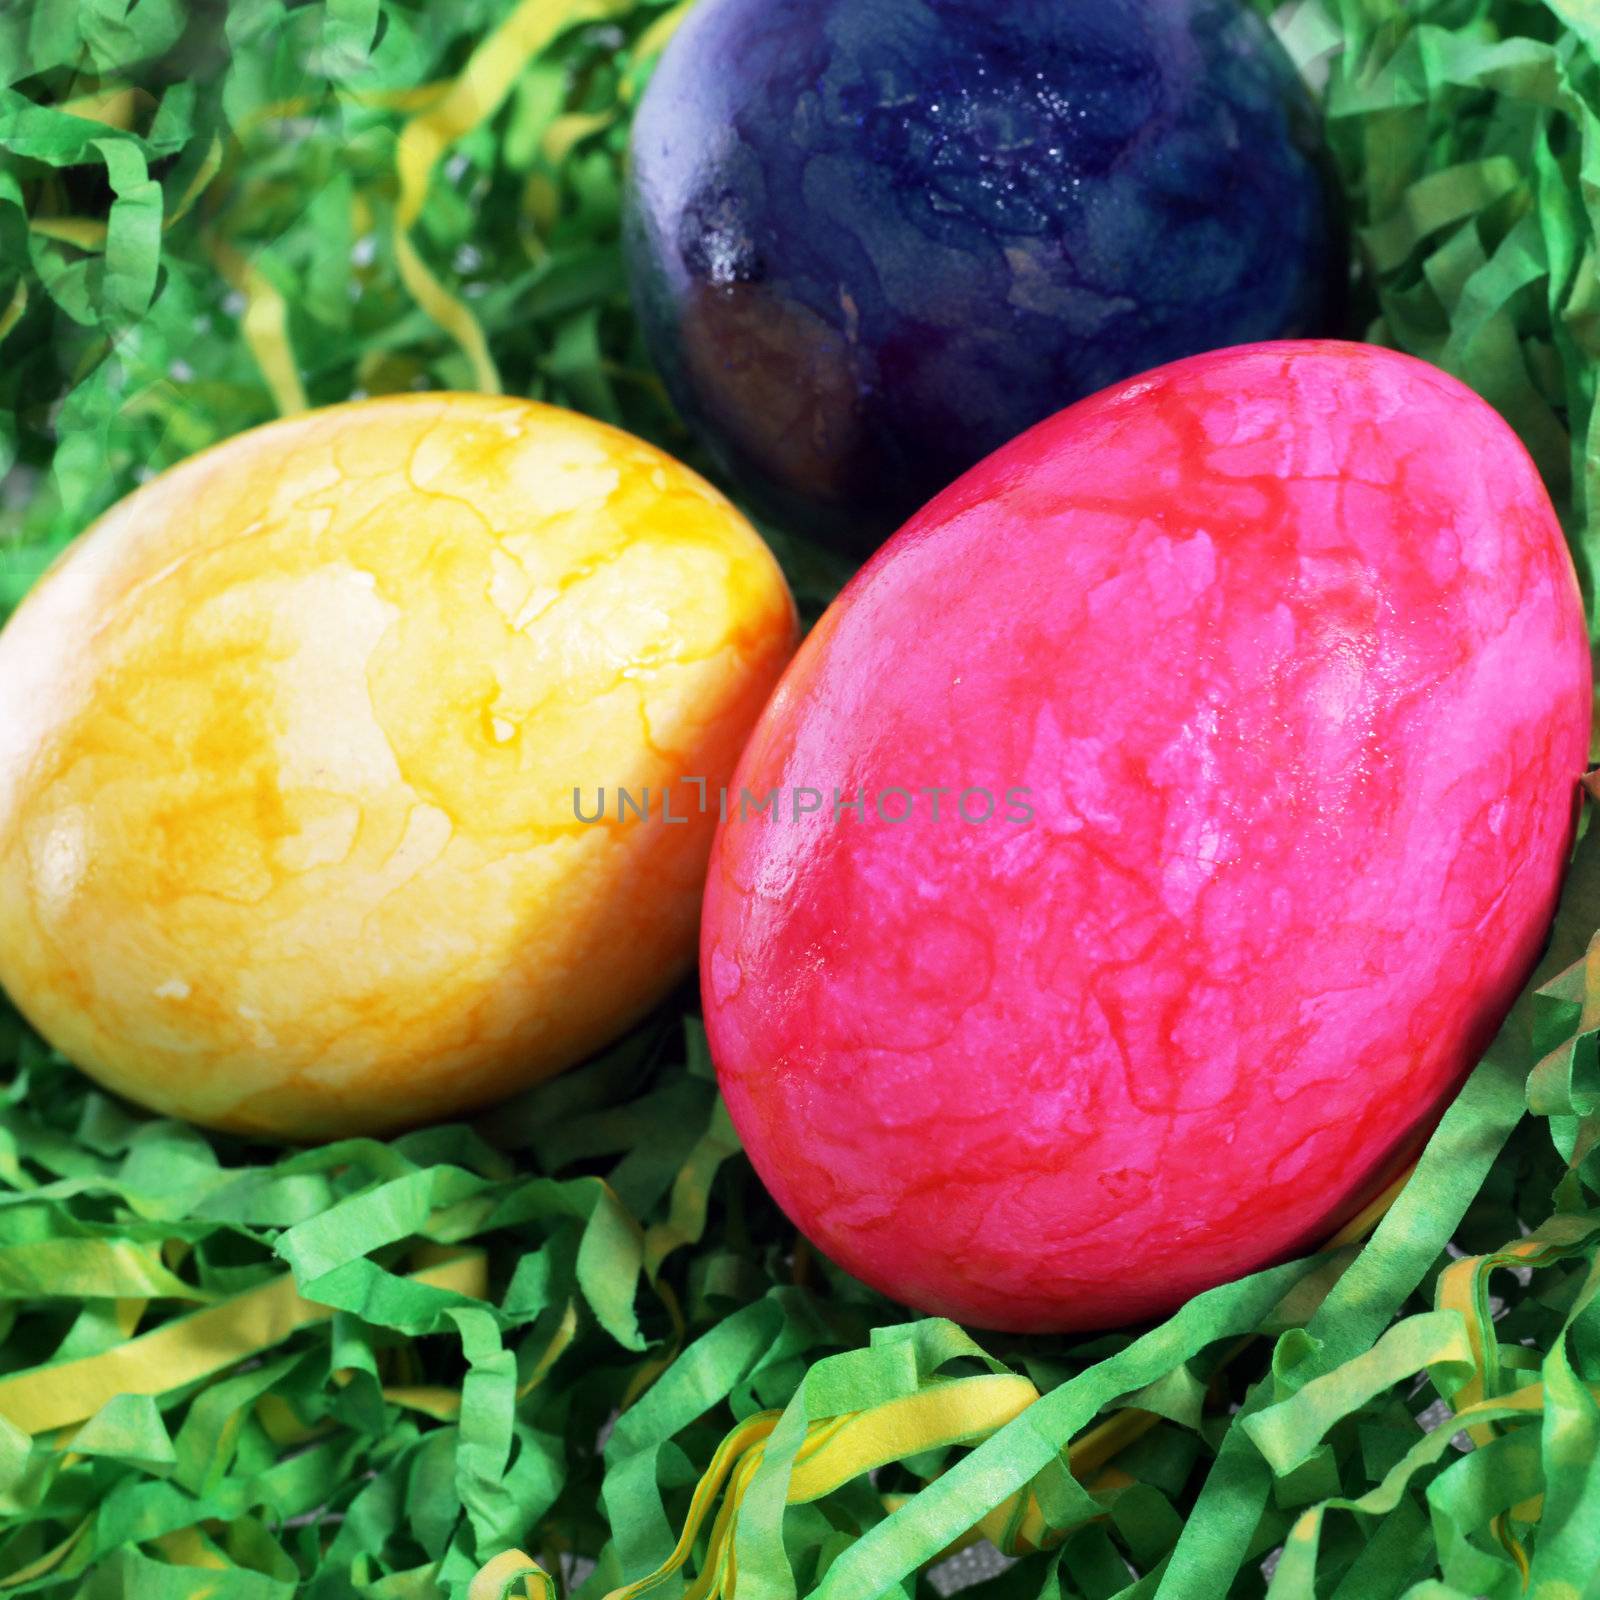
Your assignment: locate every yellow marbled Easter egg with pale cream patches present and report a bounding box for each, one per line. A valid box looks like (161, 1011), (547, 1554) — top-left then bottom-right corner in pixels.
(0, 394), (795, 1139)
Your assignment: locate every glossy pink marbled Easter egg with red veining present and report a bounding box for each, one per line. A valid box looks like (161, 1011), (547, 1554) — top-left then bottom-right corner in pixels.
(701, 342), (1589, 1330)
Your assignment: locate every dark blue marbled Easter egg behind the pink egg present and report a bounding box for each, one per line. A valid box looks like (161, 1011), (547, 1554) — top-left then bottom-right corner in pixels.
(626, 0), (1346, 544)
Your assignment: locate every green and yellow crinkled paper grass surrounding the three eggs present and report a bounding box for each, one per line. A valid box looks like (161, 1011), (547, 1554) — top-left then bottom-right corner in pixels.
(0, 0), (1600, 1600)
